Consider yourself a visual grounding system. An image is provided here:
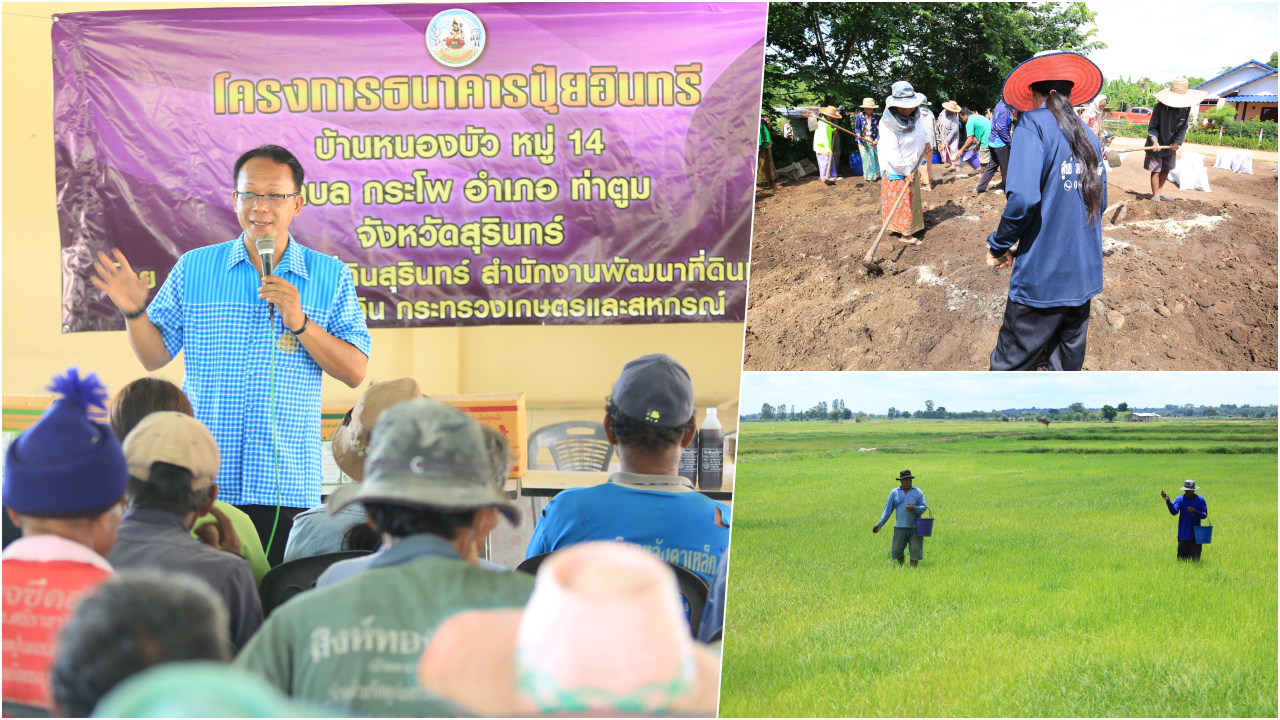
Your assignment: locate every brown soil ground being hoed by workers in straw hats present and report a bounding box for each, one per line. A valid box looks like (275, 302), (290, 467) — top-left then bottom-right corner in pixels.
(744, 159), (1276, 370)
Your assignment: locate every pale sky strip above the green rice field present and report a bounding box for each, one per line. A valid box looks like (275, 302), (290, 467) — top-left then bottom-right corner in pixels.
(741, 372), (1276, 415)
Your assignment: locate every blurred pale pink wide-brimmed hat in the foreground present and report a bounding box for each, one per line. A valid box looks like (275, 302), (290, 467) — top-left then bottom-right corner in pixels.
(417, 542), (719, 717)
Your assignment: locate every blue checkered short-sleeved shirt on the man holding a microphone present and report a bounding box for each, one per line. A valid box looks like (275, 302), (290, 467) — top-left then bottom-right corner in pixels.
(147, 234), (370, 507)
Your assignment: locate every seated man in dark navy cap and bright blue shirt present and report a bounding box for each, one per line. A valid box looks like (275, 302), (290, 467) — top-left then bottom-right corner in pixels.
(527, 354), (730, 583)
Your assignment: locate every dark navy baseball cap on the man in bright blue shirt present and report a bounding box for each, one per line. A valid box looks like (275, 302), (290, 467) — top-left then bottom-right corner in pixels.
(613, 352), (694, 428)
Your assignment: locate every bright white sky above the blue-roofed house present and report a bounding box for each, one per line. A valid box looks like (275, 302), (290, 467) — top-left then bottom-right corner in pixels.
(1088, 0), (1280, 82)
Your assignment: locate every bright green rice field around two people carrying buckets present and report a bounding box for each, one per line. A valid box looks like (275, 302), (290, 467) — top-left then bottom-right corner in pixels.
(721, 420), (1277, 717)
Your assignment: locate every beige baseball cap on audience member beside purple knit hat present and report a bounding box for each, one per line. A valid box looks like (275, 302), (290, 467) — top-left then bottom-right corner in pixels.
(124, 410), (223, 491)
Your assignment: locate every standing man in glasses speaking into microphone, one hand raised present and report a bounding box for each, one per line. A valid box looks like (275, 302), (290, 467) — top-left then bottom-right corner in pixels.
(93, 145), (370, 565)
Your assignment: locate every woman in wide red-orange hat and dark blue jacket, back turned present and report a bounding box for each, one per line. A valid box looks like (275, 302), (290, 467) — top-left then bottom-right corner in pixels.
(987, 50), (1107, 370)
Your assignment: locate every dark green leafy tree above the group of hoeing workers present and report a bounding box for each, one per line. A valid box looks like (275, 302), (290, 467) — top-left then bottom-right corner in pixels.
(763, 3), (1106, 109)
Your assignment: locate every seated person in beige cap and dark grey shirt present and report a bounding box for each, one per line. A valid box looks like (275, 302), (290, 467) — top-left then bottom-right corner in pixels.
(108, 411), (262, 648)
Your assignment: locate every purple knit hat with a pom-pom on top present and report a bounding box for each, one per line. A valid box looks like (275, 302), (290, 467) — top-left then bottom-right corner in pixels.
(4, 368), (129, 516)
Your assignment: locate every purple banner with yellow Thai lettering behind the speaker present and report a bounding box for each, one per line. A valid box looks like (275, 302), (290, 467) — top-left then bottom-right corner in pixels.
(52, 3), (767, 332)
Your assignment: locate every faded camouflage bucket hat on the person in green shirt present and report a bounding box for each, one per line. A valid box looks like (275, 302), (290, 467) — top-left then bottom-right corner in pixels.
(326, 397), (520, 525)
